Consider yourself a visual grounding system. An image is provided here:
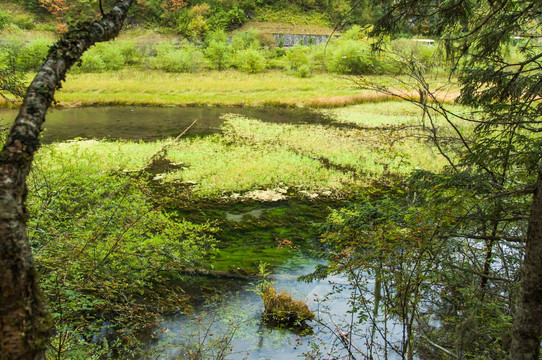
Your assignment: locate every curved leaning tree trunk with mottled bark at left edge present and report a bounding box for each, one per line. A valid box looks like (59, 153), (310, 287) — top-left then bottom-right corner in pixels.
(0, 0), (134, 360)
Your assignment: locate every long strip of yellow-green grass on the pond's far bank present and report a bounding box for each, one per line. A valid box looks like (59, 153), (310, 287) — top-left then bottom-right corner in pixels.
(4, 68), (460, 108)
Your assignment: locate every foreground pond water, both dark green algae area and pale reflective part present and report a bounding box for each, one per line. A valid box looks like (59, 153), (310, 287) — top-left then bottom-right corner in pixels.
(148, 200), (406, 360)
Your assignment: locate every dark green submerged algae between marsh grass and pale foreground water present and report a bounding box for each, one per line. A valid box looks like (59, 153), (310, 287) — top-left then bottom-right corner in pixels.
(177, 200), (337, 276)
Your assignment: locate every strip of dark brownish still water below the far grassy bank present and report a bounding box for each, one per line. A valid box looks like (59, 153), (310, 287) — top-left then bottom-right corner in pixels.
(0, 106), (331, 143)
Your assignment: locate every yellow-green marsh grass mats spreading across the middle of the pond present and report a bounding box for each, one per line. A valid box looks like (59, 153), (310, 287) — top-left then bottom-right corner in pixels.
(31, 103), (452, 197)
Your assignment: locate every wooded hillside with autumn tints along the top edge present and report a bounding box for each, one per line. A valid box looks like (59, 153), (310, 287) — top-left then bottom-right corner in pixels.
(0, 0), (430, 40)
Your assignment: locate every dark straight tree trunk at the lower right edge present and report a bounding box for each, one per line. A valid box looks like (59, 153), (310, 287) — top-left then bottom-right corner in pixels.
(510, 163), (542, 360)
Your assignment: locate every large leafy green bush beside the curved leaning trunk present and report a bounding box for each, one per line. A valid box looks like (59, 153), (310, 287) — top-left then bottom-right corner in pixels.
(28, 142), (219, 359)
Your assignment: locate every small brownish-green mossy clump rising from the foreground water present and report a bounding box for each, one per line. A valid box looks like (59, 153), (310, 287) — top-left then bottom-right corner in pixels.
(262, 285), (315, 333)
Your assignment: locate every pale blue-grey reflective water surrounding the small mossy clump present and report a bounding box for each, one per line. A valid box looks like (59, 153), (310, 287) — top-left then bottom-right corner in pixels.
(156, 258), (356, 360)
